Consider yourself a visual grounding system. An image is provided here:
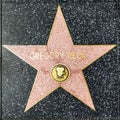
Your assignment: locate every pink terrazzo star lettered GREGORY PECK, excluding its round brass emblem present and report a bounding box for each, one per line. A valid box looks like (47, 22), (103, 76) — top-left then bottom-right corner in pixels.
(4, 6), (115, 111)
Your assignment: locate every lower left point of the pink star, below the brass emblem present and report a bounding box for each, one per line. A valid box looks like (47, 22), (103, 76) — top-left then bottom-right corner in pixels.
(25, 70), (59, 111)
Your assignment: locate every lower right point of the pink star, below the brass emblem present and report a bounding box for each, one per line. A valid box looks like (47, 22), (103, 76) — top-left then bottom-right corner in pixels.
(61, 71), (95, 110)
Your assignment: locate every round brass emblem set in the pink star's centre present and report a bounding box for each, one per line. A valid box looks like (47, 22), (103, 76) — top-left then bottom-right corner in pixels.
(51, 64), (69, 82)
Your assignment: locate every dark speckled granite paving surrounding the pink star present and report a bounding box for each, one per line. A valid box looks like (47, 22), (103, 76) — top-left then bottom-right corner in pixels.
(2, 0), (120, 120)
